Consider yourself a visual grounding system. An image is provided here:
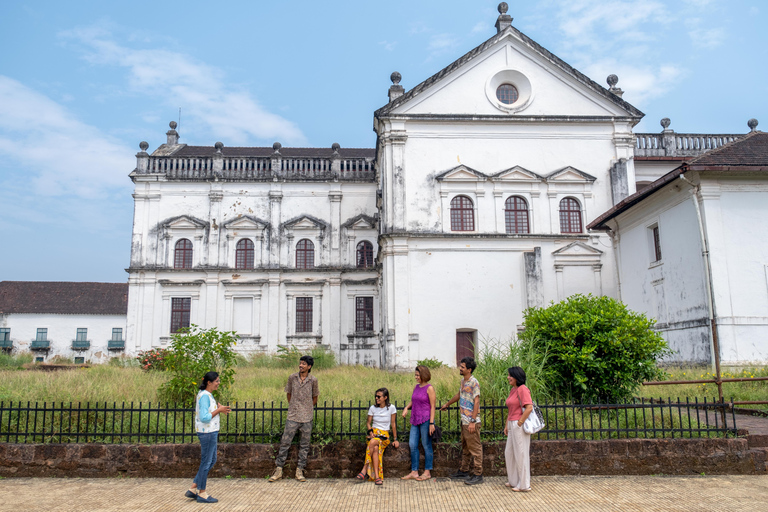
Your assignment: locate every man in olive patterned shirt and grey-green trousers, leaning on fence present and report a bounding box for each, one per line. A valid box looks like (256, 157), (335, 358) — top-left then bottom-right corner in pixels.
(269, 356), (320, 482)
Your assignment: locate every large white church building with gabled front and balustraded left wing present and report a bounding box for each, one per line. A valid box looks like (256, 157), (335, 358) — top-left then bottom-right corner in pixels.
(117, 4), (768, 368)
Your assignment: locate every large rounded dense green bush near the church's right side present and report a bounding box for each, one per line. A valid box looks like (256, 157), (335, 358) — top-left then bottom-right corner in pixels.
(520, 295), (671, 402)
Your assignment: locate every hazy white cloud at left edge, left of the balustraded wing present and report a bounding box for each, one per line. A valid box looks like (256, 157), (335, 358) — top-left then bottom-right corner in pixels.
(0, 75), (135, 198)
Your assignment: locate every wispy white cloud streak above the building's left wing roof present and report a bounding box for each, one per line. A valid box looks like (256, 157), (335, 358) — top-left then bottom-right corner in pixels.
(61, 26), (306, 145)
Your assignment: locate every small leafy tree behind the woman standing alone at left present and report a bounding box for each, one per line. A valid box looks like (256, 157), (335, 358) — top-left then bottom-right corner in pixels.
(159, 325), (237, 404)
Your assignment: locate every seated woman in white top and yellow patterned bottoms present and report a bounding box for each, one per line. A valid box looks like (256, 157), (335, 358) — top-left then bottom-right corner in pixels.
(355, 388), (400, 485)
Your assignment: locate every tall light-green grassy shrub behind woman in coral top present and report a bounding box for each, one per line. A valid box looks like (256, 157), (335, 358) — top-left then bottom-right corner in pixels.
(474, 336), (552, 403)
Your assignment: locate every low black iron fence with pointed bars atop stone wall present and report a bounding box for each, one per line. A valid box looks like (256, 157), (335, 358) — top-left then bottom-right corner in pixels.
(0, 398), (736, 443)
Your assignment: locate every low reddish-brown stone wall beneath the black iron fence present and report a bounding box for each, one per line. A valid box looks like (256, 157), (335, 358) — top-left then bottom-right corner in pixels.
(0, 438), (768, 478)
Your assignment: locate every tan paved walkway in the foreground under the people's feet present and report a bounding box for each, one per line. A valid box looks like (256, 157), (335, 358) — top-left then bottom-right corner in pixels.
(0, 476), (768, 512)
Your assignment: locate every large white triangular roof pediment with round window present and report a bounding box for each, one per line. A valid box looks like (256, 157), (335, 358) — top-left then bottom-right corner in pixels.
(375, 27), (643, 119)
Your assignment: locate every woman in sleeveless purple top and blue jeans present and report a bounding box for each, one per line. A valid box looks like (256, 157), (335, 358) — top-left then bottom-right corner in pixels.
(401, 365), (435, 481)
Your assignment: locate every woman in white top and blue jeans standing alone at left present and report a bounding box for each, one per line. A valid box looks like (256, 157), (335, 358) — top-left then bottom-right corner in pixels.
(184, 372), (230, 503)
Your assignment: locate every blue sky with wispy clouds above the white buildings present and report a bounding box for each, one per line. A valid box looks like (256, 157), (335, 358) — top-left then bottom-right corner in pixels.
(0, 0), (768, 282)
